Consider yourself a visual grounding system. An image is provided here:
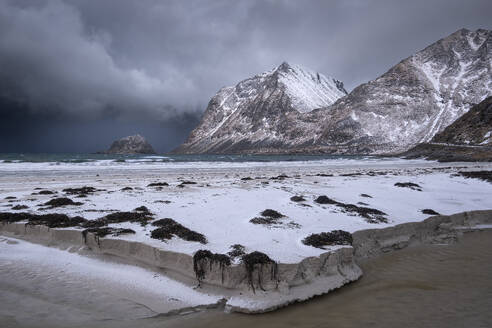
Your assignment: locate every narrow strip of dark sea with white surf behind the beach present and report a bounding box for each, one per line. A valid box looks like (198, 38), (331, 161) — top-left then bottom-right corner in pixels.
(0, 153), (435, 176)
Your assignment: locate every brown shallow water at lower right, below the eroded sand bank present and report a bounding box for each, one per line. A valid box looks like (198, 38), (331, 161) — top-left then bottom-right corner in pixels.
(165, 231), (492, 328)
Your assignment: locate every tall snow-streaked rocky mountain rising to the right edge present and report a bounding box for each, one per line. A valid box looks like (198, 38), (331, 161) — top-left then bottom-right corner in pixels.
(316, 29), (492, 153)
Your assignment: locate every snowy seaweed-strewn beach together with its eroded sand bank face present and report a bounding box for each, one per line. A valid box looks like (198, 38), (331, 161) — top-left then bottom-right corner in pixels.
(0, 159), (492, 313)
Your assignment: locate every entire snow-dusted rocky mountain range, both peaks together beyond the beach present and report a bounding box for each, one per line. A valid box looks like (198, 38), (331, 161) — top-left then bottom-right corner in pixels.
(176, 29), (492, 154)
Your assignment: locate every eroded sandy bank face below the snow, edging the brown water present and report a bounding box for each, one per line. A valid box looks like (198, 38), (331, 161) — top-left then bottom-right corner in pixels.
(0, 210), (492, 313)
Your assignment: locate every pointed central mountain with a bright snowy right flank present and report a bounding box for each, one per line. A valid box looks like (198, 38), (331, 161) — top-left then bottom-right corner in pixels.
(176, 63), (347, 153)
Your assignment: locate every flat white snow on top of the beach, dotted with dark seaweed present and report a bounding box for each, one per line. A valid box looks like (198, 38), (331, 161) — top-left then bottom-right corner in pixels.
(0, 157), (492, 312)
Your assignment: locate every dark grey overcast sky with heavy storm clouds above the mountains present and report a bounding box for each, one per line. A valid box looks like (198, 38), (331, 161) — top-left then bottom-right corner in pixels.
(0, 0), (492, 152)
